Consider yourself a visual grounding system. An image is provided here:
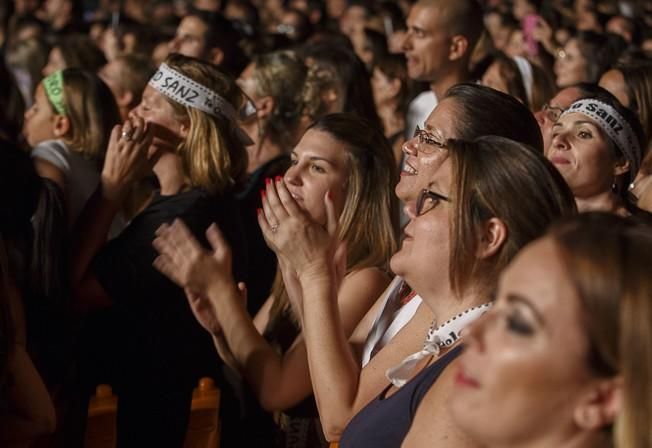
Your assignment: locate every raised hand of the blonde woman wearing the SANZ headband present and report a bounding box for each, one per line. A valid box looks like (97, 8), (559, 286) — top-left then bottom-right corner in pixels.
(101, 117), (152, 201)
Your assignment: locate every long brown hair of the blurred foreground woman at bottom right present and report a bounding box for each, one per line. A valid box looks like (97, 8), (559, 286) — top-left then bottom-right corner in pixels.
(550, 212), (652, 448)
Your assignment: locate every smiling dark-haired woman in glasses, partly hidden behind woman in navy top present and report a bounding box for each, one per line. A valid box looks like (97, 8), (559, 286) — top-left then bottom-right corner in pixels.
(241, 84), (552, 440)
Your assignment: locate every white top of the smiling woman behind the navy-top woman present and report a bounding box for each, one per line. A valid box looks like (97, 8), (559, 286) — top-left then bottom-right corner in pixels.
(362, 276), (422, 367)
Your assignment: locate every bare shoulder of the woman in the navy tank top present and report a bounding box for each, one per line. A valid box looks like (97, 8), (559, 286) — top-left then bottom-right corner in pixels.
(402, 359), (480, 448)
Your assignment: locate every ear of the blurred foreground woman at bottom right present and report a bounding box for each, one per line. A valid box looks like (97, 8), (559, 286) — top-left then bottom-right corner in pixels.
(573, 376), (623, 431)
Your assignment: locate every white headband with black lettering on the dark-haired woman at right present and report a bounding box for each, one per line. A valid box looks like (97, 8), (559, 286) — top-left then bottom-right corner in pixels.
(560, 99), (642, 179)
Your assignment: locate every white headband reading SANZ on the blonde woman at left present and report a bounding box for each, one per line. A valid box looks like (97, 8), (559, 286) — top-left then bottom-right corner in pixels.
(149, 64), (253, 145)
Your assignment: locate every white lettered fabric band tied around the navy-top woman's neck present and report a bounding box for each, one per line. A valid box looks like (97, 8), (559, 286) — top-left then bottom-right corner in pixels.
(385, 302), (492, 387)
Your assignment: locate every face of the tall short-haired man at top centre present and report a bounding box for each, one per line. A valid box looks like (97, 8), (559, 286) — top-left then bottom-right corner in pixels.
(403, 3), (450, 82)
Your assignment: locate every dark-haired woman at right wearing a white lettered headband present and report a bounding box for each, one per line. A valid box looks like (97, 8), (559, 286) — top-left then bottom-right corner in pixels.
(547, 91), (650, 219)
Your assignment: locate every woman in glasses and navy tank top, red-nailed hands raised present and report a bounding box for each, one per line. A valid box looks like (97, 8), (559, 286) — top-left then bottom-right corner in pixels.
(262, 136), (575, 447)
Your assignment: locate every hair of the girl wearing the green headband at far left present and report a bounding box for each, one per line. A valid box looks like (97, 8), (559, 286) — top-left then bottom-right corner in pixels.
(63, 68), (120, 167)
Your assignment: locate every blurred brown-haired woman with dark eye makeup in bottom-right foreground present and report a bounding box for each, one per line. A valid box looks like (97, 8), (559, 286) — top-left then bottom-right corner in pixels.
(449, 212), (652, 448)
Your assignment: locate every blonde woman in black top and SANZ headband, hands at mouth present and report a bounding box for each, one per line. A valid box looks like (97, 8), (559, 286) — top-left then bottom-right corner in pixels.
(73, 55), (247, 446)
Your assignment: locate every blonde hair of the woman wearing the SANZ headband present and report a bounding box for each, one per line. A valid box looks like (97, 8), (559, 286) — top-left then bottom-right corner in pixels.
(164, 54), (247, 193)
